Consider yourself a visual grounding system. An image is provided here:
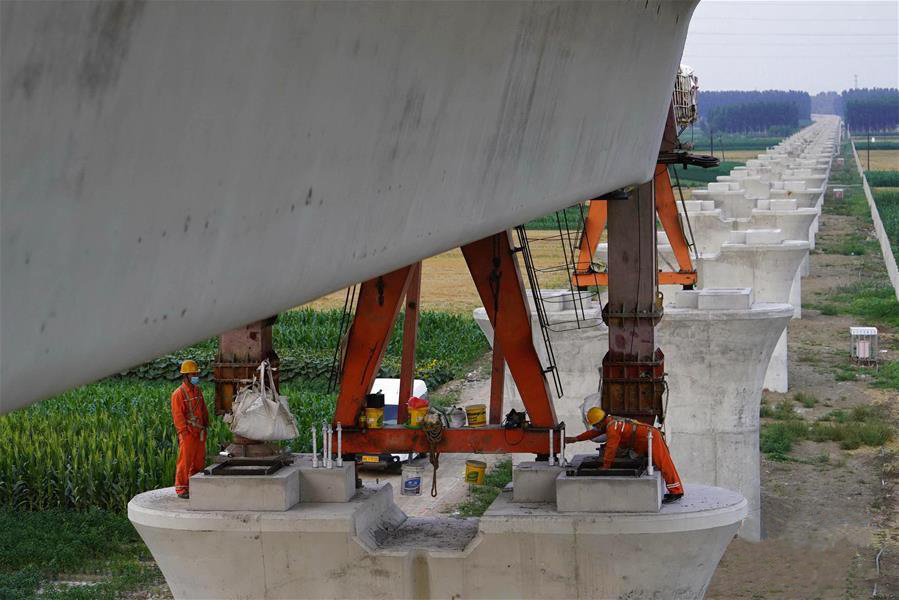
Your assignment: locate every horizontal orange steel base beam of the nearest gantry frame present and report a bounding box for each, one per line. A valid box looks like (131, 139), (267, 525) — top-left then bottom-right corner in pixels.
(340, 425), (562, 454)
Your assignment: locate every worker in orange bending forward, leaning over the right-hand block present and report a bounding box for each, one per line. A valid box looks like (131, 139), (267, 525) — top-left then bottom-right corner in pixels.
(565, 406), (684, 504)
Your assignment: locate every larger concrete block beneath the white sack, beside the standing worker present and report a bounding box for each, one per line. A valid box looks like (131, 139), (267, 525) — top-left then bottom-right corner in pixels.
(189, 464), (300, 511)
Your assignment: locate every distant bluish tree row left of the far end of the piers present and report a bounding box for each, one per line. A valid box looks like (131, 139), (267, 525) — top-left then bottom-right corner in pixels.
(699, 90), (812, 133)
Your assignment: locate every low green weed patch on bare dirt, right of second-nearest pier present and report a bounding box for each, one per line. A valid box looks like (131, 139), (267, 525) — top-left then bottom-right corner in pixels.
(759, 401), (894, 460)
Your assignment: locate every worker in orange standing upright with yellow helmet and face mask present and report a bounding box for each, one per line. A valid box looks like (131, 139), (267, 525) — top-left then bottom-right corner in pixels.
(172, 360), (209, 498)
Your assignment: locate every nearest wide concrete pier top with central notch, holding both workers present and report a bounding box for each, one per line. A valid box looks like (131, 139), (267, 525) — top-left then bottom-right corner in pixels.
(128, 476), (746, 600)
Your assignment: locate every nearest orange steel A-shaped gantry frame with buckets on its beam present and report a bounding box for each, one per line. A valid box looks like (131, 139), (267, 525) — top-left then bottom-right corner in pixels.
(334, 231), (561, 454)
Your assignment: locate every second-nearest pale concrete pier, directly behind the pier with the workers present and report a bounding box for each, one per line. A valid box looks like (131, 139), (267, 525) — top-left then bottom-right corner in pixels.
(475, 288), (793, 541)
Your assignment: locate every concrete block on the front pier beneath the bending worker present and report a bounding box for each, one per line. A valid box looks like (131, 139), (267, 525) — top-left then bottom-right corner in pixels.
(556, 471), (665, 513)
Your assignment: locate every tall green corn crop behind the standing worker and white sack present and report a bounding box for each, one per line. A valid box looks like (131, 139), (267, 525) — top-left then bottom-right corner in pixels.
(0, 380), (334, 511)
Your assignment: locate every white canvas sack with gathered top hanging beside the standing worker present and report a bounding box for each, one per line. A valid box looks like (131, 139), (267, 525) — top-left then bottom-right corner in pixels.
(224, 360), (300, 442)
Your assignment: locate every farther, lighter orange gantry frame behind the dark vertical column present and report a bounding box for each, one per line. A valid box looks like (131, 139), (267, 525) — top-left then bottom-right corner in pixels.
(571, 163), (696, 287)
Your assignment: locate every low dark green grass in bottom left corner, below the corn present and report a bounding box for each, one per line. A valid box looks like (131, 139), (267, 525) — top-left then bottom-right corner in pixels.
(0, 510), (162, 600)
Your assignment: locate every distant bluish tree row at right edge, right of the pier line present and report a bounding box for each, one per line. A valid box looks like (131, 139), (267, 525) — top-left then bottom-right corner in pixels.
(812, 88), (899, 132)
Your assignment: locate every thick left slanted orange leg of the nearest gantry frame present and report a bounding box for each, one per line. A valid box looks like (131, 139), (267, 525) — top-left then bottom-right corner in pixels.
(334, 265), (414, 425)
